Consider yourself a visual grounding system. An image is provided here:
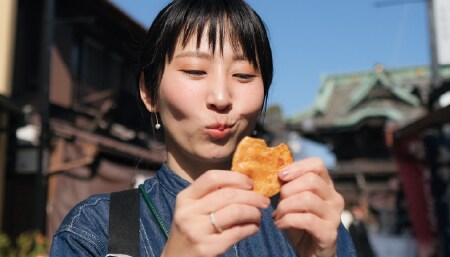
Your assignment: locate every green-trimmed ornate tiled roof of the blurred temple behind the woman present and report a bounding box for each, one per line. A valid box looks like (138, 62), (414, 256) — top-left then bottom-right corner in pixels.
(288, 66), (450, 133)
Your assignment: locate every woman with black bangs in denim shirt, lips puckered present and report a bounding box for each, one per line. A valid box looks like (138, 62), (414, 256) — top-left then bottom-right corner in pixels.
(51, 0), (354, 257)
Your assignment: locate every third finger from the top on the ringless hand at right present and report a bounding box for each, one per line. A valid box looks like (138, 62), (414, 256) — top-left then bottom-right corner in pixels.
(272, 191), (339, 220)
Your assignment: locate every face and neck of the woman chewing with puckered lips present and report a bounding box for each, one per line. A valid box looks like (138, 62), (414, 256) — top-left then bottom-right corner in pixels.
(156, 31), (264, 173)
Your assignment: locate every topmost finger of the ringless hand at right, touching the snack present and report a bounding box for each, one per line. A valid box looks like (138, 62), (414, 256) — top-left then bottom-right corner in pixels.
(278, 158), (333, 186)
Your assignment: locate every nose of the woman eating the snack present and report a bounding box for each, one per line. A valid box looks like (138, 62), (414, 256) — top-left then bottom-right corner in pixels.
(206, 78), (232, 112)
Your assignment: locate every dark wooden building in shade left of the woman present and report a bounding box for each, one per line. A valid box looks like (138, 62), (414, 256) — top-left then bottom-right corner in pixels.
(0, 0), (165, 239)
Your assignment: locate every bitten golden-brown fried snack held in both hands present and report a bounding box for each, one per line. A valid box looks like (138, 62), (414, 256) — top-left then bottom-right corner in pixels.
(231, 137), (294, 197)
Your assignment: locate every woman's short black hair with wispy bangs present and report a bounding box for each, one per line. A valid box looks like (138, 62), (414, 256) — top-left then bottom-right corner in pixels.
(138, 0), (273, 108)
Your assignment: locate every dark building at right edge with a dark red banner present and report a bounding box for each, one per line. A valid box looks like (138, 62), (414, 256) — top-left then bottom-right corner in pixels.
(391, 77), (450, 256)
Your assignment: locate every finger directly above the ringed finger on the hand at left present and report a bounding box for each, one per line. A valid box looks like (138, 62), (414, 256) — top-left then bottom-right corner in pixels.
(201, 187), (270, 213)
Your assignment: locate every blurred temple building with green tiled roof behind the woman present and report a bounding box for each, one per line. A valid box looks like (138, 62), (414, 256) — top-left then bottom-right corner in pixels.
(288, 65), (450, 233)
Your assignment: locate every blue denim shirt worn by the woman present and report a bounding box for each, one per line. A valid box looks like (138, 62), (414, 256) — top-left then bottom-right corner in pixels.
(50, 164), (356, 257)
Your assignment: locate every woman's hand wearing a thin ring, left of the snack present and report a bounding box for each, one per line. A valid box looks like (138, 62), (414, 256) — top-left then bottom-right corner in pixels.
(162, 170), (270, 257)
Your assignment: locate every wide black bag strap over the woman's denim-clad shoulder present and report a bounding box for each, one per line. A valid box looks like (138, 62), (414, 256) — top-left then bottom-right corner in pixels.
(107, 189), (140, 257)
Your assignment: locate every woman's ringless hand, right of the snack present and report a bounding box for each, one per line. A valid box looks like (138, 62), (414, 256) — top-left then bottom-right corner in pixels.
(272, 158), (344, 257)
